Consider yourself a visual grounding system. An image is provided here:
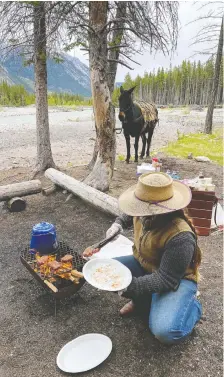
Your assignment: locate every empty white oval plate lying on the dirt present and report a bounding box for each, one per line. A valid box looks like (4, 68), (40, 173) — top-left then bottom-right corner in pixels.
(57, 334), (112, 373)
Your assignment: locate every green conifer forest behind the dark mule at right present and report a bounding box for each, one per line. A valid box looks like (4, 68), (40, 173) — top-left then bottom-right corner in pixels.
(113, 59), (223, 106)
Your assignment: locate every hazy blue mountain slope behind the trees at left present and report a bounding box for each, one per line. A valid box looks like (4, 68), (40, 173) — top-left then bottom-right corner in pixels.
(0, 54), (91, 97)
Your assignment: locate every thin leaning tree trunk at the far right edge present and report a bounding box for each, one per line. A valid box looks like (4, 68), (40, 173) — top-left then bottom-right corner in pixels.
(204, 19), (223, 134)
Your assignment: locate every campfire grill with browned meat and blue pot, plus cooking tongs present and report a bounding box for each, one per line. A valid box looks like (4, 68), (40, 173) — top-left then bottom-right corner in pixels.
(20, 222), (122, 298)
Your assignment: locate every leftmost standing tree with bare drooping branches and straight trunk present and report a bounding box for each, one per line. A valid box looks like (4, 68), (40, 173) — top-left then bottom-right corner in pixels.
(0, 1), (76, 173)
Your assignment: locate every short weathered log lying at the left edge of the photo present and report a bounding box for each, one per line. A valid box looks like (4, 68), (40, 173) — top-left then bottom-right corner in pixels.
(0, 179), (41, 201)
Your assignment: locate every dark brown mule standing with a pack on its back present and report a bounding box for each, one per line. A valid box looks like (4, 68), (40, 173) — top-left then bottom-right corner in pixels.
(119, 86), (158, 163)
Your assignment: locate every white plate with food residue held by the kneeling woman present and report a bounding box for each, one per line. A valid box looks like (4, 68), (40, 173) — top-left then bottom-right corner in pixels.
(82, 258), (132, 292)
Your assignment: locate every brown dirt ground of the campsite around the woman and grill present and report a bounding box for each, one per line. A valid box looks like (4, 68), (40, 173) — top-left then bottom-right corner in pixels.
(0, 156), (222, 377)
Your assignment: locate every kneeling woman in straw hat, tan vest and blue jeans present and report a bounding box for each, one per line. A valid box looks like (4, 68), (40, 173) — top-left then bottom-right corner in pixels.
(83, 173), (202, 344)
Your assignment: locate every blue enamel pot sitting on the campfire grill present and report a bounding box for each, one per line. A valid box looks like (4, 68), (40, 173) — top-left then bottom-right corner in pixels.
(30, 222), (58, 255)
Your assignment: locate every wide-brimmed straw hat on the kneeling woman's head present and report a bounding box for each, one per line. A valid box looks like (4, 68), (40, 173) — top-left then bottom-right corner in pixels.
(119, 172), (192, 216)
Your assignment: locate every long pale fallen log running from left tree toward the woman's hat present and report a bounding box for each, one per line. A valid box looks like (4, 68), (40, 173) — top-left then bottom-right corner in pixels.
(45, 168), (120, 216)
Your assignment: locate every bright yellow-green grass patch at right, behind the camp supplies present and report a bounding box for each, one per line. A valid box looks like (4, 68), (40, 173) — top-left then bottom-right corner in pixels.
(161, 130), (223, 165)
